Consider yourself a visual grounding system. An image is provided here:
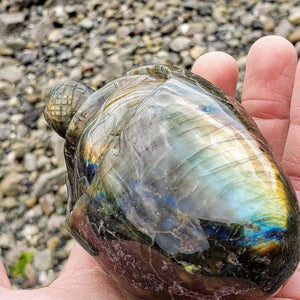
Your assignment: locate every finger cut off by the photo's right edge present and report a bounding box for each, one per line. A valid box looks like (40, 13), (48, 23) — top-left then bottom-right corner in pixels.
(282, 63), (300, 199)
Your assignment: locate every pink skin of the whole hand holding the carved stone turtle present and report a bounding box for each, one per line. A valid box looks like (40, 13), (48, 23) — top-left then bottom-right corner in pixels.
(0, 36), (300, 300)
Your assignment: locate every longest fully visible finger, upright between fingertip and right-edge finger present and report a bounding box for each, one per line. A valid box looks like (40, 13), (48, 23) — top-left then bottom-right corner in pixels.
(242, 36), (297, 159)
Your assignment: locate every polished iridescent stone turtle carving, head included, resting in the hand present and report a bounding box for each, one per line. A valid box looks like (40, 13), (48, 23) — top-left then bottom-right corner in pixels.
(45, 65), (300, 300)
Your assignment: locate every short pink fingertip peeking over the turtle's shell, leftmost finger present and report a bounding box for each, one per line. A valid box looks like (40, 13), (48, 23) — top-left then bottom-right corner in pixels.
(192, 52), (238, 96)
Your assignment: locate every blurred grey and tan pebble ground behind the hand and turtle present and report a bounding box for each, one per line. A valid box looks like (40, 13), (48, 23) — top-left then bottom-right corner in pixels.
(0, 0), (300, 288)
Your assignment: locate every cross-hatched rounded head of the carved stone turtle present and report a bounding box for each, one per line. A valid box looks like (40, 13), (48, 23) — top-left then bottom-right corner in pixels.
(44, 81), (94, 138)
